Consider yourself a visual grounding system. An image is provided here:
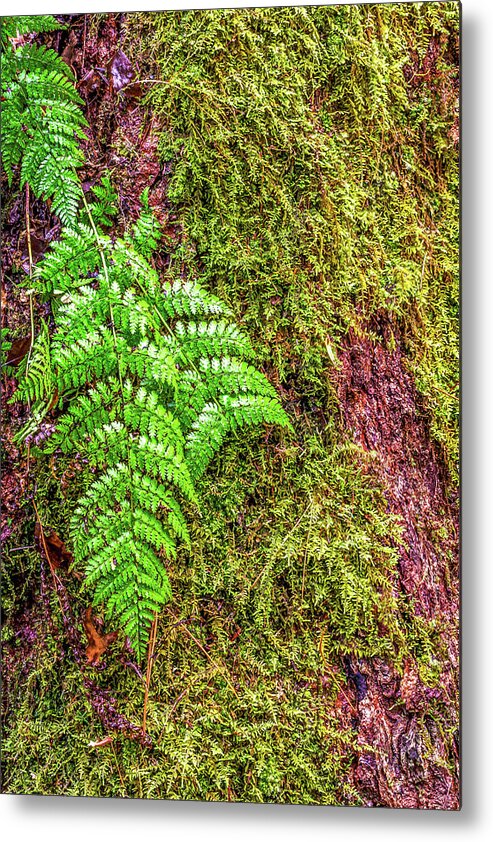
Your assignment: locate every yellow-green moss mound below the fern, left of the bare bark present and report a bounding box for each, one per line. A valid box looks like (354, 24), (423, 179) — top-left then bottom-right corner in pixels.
(4, 416), (436, 804)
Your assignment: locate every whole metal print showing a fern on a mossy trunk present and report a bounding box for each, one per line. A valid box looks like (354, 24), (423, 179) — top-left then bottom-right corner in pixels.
(1, 2), (460, 810)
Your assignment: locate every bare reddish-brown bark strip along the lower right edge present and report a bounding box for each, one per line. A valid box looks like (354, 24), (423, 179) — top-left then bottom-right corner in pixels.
(337, 316), (459, 810)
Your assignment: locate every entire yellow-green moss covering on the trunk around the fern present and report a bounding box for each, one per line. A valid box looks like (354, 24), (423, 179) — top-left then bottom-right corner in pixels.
(3, 3), (458, 804)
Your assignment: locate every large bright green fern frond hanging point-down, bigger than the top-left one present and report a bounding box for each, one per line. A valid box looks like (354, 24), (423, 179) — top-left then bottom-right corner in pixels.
(17, 197), (290, 657)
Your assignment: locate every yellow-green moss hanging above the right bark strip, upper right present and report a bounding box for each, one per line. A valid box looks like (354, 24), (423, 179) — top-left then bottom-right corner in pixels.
(129, 2), (459, 478)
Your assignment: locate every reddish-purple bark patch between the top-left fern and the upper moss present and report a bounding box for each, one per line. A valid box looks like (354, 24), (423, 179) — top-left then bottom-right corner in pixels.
(49, 13), (175, 237)
